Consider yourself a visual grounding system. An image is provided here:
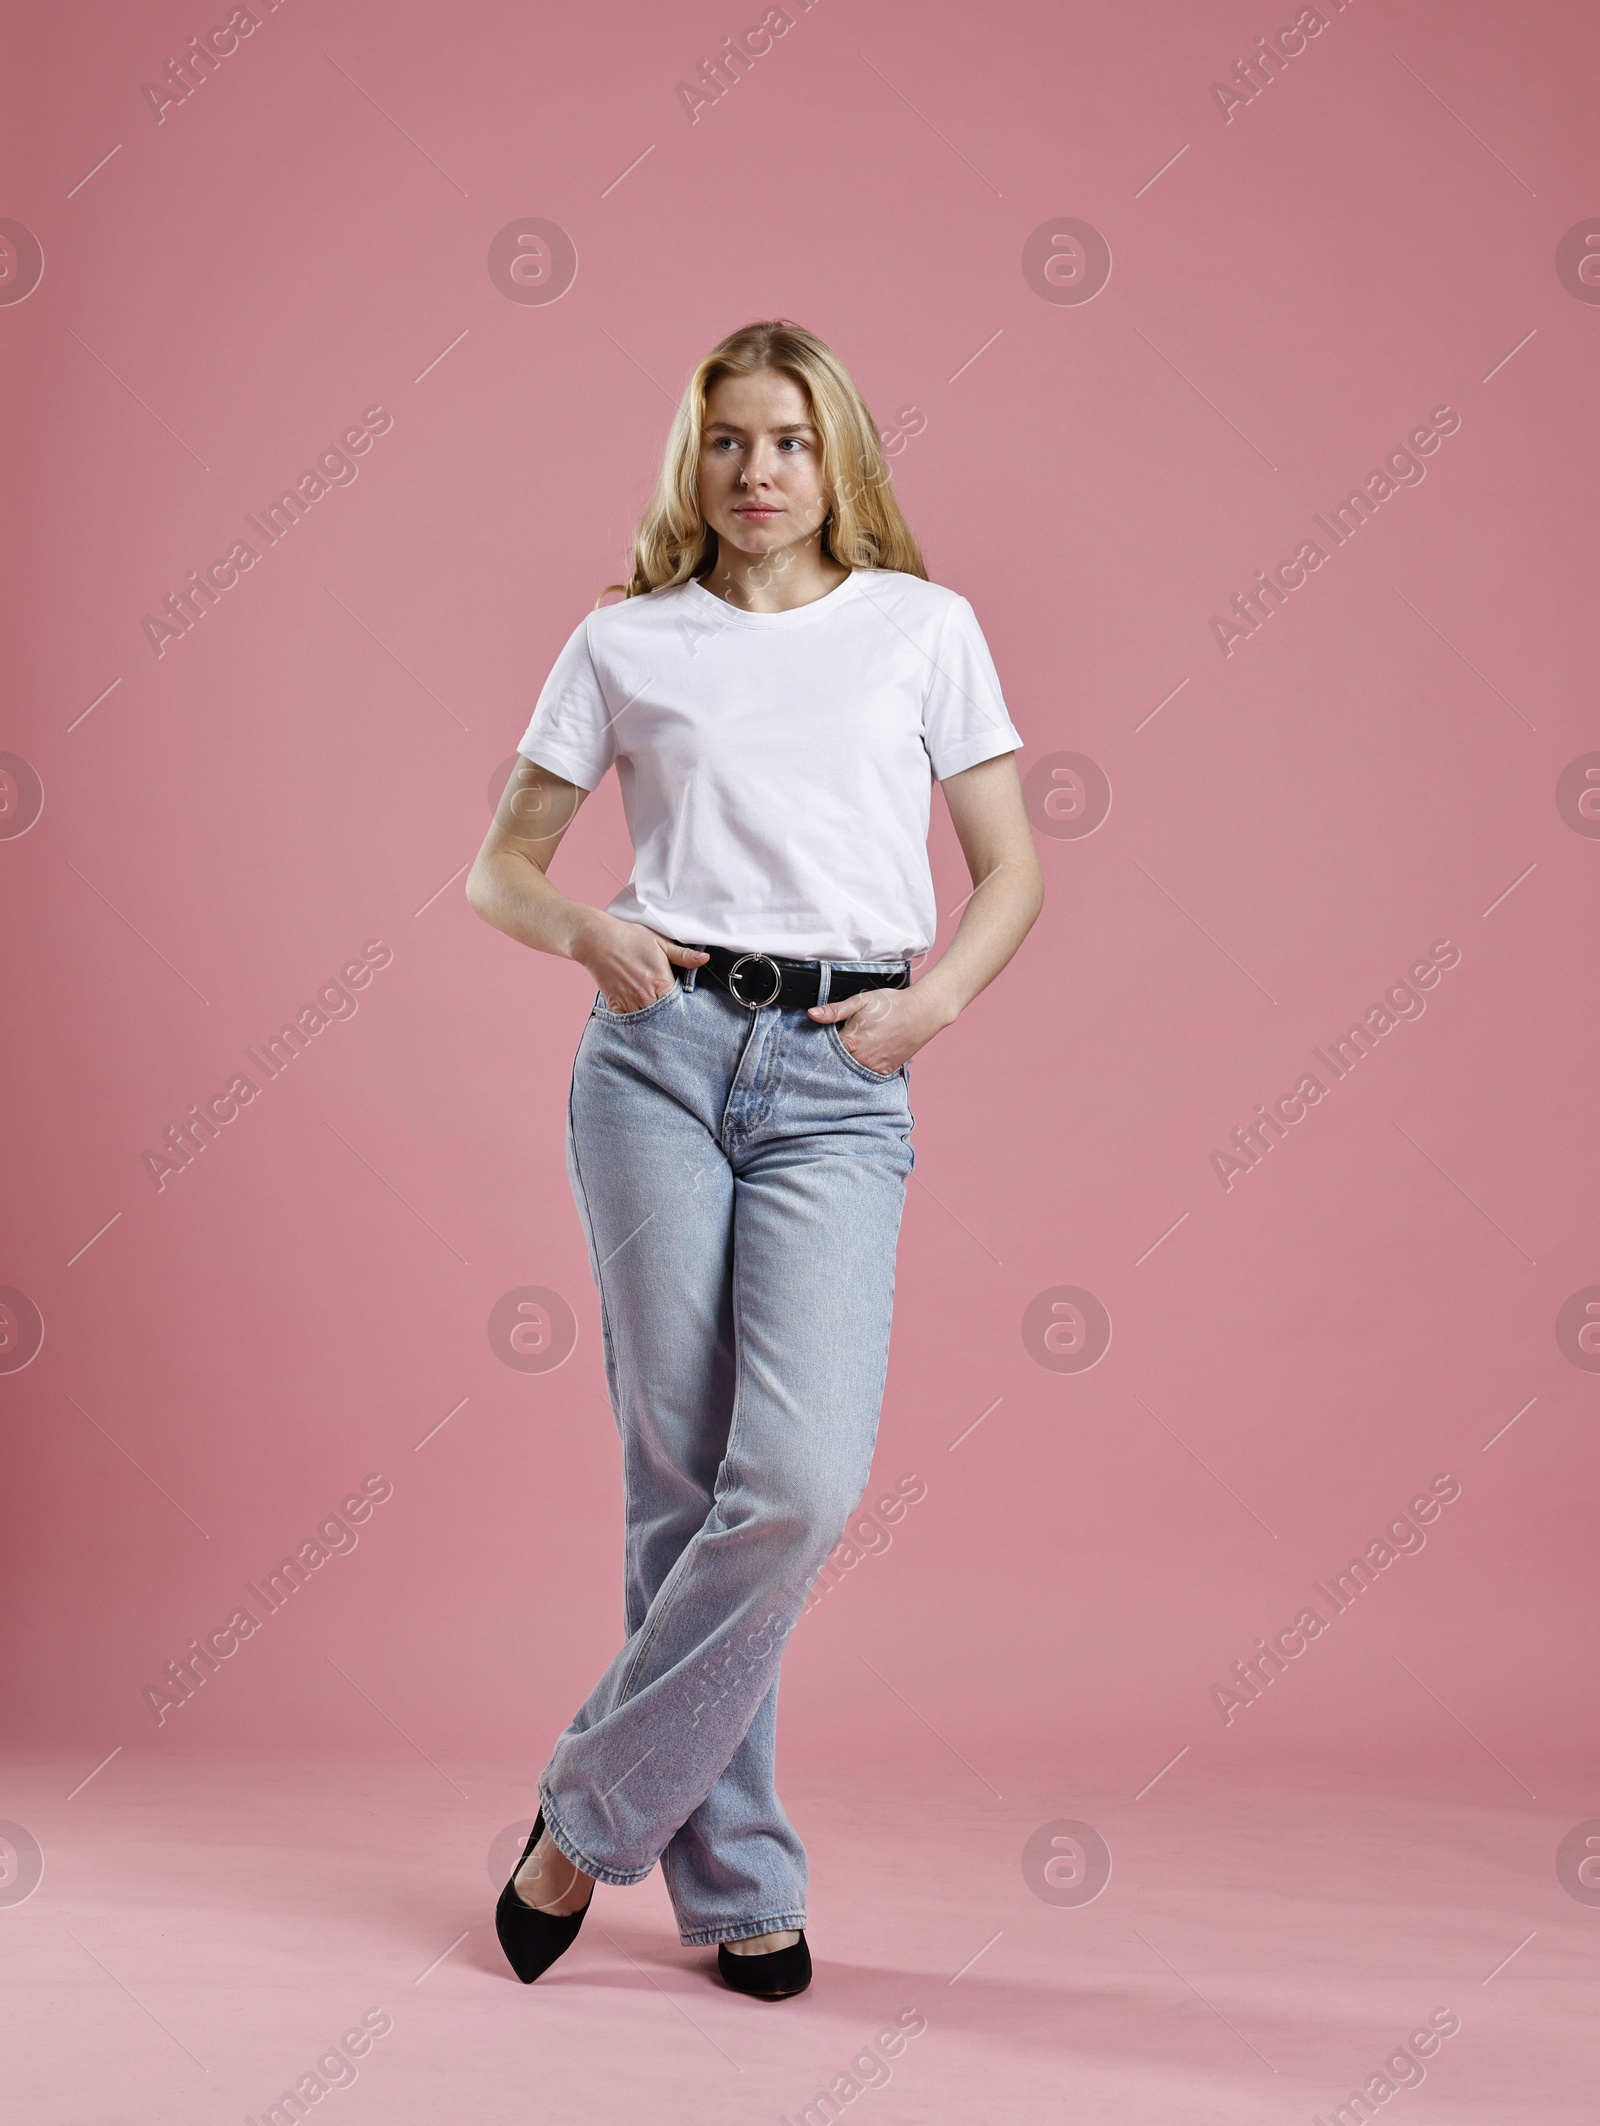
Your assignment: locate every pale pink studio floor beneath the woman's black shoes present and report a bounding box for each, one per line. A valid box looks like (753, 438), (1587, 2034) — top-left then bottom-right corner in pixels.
(0, 1748), (1600, 2126)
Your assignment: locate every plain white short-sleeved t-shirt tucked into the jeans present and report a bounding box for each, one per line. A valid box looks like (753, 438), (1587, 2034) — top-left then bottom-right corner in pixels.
(516, 570), (1022, 961)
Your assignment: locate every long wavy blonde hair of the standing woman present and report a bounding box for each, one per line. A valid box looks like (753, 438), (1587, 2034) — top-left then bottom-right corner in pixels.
(595, 317), (929, 606)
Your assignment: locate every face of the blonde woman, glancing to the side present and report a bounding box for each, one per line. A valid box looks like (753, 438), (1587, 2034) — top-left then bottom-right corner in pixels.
(699, 370), (829, 555)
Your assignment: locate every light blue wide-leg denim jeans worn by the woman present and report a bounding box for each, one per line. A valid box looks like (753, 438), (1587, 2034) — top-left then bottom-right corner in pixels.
(540, 961), (912, 1943)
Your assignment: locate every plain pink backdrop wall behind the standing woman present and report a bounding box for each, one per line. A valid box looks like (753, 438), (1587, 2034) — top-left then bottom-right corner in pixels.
(0, 0), (1600, 2115)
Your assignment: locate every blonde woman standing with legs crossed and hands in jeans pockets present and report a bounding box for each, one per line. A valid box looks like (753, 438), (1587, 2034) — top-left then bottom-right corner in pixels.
(467, 321), (1043, 2001)
